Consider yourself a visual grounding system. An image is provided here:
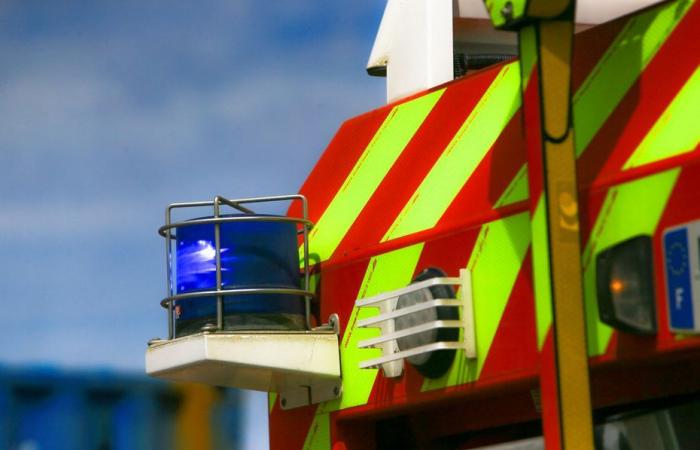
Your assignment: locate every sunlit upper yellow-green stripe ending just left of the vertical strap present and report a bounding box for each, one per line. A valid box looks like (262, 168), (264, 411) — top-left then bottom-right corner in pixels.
(382, 63), (520, 241)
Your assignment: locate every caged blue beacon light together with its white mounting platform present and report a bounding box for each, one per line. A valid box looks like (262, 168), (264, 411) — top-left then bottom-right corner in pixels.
(145, 195), (343, 409)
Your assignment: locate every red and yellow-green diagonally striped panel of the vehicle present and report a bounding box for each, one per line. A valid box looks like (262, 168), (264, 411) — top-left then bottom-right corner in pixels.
(270, 1), (700, 449)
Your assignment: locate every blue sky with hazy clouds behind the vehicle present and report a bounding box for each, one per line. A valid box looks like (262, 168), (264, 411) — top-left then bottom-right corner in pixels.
(0, 0), (385, 446)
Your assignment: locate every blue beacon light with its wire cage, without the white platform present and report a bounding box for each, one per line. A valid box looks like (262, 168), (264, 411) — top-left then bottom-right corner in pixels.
(161, 196), (313, 338)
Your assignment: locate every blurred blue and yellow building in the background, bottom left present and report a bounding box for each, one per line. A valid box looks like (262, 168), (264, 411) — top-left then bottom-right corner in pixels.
(0, 366), (242, 450)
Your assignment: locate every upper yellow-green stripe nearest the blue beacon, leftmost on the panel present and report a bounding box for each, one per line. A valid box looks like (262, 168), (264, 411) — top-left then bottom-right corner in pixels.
(309, 89), (445, 261)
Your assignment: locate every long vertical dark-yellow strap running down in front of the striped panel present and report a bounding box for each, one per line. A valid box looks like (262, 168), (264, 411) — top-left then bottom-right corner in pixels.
(533, 15), (593, 450)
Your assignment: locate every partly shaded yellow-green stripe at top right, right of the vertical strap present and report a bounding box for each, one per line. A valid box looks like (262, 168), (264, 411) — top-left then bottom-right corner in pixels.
(573, 1), (694, 155)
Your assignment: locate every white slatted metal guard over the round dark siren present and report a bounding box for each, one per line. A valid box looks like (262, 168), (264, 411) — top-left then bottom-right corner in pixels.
(355, 269), (476, 378)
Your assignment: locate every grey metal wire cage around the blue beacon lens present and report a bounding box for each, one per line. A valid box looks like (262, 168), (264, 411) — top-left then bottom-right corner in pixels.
(158, 194), (316, 339)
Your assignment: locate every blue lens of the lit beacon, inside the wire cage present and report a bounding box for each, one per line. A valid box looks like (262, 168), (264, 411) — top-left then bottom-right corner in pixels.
(172, 216), (304, 335)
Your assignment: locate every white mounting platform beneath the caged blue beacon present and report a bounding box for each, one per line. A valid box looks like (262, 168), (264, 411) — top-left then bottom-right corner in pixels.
(146, 331), (341, 409)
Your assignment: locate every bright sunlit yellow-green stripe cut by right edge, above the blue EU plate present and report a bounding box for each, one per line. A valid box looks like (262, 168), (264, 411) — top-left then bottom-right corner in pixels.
(624, 67), (700, 169)
